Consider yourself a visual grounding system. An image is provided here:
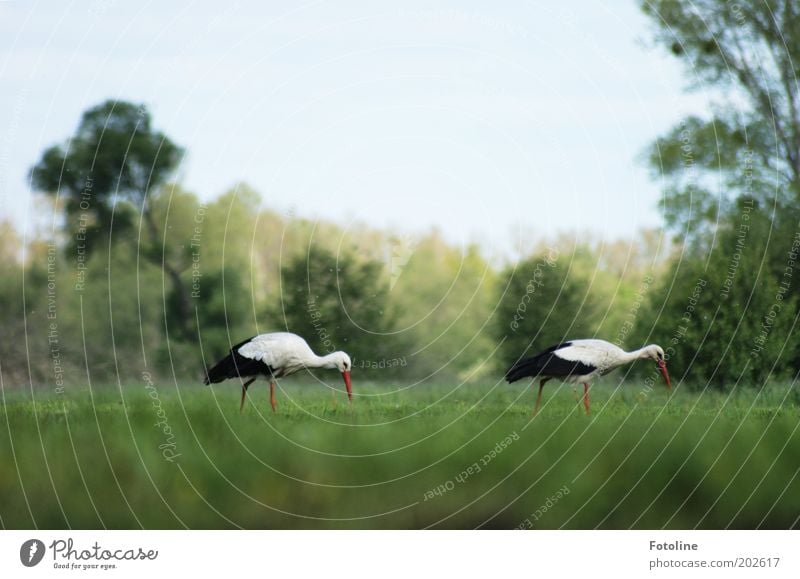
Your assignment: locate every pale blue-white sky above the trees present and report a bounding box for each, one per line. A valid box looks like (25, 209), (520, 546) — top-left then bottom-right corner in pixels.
(0, 0), (708, 252)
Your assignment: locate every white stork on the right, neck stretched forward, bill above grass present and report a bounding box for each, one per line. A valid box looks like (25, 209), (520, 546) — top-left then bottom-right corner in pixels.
(506, 340), (672, 414)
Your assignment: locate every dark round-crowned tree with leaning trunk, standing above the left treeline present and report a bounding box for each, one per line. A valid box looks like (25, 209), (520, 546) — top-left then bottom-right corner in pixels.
(30, 101), (191, 337)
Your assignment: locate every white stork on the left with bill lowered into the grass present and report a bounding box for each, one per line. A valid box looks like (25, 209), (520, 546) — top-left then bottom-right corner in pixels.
(204, 332), (353, 412)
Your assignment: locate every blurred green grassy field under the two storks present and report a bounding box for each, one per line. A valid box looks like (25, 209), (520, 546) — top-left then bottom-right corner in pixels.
(0, 380), (800, 529)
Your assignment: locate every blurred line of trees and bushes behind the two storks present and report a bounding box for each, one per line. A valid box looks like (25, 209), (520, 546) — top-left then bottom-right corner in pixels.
(0, 0), (800, 390)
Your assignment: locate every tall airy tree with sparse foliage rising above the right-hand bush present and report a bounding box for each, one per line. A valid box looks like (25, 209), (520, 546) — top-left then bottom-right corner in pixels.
(642, 0), (800, 239)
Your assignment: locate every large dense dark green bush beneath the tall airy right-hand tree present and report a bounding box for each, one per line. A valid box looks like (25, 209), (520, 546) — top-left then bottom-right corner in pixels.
(635, 200), (800, 391)
